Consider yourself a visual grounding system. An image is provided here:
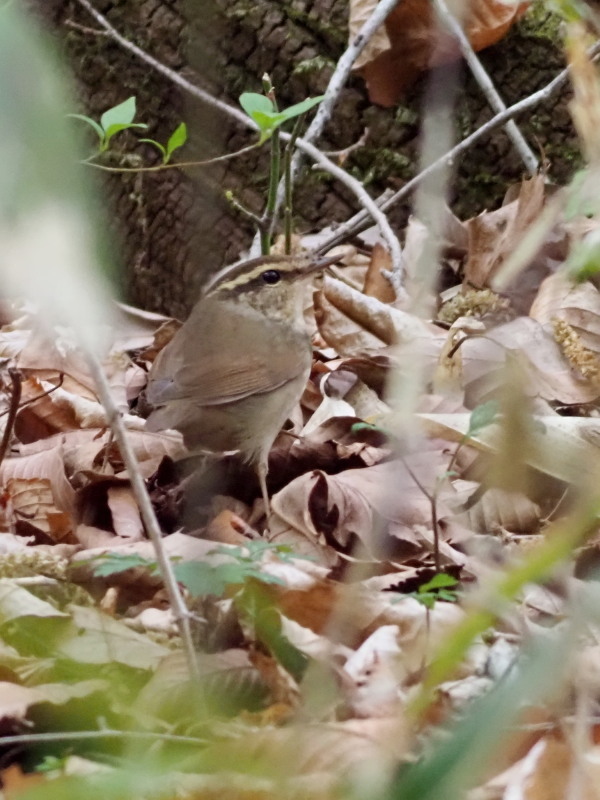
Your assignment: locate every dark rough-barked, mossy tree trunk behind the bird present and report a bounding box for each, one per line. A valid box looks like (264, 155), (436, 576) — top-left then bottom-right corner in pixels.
(29, 0), (579, 316)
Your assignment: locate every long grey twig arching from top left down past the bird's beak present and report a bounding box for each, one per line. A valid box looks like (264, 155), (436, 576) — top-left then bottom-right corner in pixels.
(77, 0), (402, 273)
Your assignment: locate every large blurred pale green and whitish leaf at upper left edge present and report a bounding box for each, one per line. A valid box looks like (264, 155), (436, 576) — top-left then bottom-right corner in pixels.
(0, 4), (108, 347)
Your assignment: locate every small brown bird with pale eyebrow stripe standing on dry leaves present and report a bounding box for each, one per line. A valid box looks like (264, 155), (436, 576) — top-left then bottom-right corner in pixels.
(146, 256), (337, 514)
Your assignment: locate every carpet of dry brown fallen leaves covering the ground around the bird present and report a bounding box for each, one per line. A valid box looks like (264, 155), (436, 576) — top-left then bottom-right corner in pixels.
(5, 176), (600, 798)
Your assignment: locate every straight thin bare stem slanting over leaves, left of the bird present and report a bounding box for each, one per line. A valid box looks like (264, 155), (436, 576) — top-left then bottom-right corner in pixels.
(87, 352), (200, 678)
